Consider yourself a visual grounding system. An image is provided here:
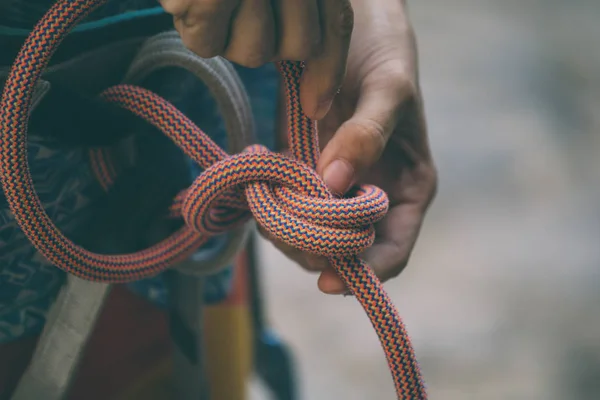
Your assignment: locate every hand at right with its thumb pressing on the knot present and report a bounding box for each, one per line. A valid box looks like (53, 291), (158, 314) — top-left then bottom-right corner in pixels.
(263, 0), (437, 294)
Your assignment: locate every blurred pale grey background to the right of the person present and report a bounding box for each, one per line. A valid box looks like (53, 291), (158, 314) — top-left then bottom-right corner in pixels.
(253, 0), (600, 400)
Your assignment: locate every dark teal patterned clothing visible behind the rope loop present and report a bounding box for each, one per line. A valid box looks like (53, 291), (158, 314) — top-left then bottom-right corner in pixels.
(0, 0), (279, 343)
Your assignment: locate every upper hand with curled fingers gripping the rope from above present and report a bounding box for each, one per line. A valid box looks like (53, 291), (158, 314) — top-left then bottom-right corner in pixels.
(160, 0), (354, 120)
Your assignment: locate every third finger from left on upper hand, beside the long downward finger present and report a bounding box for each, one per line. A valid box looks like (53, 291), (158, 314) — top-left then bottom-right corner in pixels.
(273, 0), (321, 61)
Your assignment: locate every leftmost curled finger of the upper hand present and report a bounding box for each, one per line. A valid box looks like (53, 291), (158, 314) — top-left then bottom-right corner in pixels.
(161, 0), (240, 58)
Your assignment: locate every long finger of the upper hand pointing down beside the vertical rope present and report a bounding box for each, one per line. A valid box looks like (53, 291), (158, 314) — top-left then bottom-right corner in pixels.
(300, 0), (354, 119)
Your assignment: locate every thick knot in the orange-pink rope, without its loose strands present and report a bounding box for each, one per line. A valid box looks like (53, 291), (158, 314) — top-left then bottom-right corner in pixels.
(182, 146), (388, 256)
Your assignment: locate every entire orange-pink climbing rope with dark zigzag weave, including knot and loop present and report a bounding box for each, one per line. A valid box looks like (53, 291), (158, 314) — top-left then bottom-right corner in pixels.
(0, 0), (427, 400)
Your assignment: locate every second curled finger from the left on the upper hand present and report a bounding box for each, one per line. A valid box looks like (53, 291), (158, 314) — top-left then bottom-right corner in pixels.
(223, 0), (276, 68)
